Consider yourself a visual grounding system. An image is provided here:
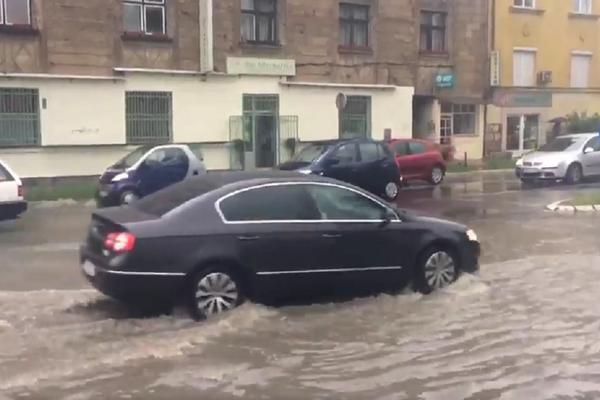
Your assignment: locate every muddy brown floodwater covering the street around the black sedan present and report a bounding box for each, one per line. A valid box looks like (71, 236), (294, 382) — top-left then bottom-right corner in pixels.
(0, 174), (600, 400)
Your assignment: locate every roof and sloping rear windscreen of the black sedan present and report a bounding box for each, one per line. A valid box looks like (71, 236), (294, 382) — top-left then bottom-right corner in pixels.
(135, 170), (340, 216)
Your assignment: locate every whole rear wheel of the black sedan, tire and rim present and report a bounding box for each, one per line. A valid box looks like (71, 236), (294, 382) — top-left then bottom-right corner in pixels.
(188, 266), (245, 320)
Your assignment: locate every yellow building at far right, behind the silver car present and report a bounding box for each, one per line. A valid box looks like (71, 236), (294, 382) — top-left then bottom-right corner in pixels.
(485, 0), (600, 155)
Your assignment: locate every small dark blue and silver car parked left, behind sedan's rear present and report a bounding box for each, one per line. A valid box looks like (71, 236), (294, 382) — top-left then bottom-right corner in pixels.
(96, 145), (206, 207)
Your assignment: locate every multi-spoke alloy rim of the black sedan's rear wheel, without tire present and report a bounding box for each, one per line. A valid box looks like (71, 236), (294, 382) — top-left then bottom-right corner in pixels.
(196, 272), (239, 316)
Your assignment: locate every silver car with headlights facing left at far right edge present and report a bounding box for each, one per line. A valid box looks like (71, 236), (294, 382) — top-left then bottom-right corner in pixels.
(515, 133), (600, 184)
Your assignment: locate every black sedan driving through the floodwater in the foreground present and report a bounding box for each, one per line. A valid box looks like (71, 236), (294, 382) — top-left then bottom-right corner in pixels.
(81, 171), (479, 318)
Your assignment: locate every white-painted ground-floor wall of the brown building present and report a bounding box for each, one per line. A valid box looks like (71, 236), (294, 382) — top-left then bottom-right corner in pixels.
(0, 74), (413, 177)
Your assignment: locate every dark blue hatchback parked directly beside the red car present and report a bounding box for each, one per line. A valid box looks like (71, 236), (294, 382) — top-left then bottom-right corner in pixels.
(279, 139), (402, 200)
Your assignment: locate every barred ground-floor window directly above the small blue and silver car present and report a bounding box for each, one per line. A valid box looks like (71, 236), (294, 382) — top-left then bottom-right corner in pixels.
(125, 92), (173, 144)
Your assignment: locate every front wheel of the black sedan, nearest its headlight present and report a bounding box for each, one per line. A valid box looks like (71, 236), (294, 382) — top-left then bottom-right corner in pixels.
(415, 246), (459, 294)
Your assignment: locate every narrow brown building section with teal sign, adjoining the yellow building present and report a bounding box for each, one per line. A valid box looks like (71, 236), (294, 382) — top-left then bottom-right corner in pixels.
(413, 0), (490, 159)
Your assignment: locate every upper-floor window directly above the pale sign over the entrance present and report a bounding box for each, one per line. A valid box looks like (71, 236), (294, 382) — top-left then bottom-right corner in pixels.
(241, 0), (277, 43)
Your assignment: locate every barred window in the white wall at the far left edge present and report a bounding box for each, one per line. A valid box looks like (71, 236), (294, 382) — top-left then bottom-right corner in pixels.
(0, 88), (40, 147)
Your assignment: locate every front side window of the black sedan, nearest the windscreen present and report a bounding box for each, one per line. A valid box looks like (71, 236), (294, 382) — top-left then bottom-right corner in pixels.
(309, 185), (388, 221)
